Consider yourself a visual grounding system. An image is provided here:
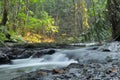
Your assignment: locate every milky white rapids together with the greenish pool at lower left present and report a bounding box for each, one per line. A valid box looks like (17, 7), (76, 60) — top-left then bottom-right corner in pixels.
(0, 54), (77, 80)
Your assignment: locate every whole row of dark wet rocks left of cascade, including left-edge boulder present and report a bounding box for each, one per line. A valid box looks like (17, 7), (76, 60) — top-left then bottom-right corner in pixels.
(0, 48), (55, 64)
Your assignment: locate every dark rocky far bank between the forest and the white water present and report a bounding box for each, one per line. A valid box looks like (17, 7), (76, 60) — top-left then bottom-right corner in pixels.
(0, 43), (97, 64)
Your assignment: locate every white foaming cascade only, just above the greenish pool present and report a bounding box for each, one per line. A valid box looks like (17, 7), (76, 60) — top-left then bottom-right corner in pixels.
(0, 52), (77, 69)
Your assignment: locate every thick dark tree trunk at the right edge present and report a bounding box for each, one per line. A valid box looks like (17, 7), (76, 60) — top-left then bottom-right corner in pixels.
(107, 0), (120, 41)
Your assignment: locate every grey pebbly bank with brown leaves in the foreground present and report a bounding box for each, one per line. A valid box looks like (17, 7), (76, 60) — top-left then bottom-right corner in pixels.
(12, 61), (120, 80)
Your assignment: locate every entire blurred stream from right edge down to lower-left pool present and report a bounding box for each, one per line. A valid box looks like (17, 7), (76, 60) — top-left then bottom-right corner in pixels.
(0, 43), (120, 80)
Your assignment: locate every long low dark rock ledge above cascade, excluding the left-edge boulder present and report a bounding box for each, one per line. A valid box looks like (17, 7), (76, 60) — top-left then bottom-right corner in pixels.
(3, 48), (55, 59)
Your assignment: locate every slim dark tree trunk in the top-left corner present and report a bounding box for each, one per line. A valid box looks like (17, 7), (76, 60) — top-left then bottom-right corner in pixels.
(0, 0), (8, 26)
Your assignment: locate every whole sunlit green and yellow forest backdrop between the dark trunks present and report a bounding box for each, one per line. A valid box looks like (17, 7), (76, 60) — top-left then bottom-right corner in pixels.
(0, 0), (111, 43)
